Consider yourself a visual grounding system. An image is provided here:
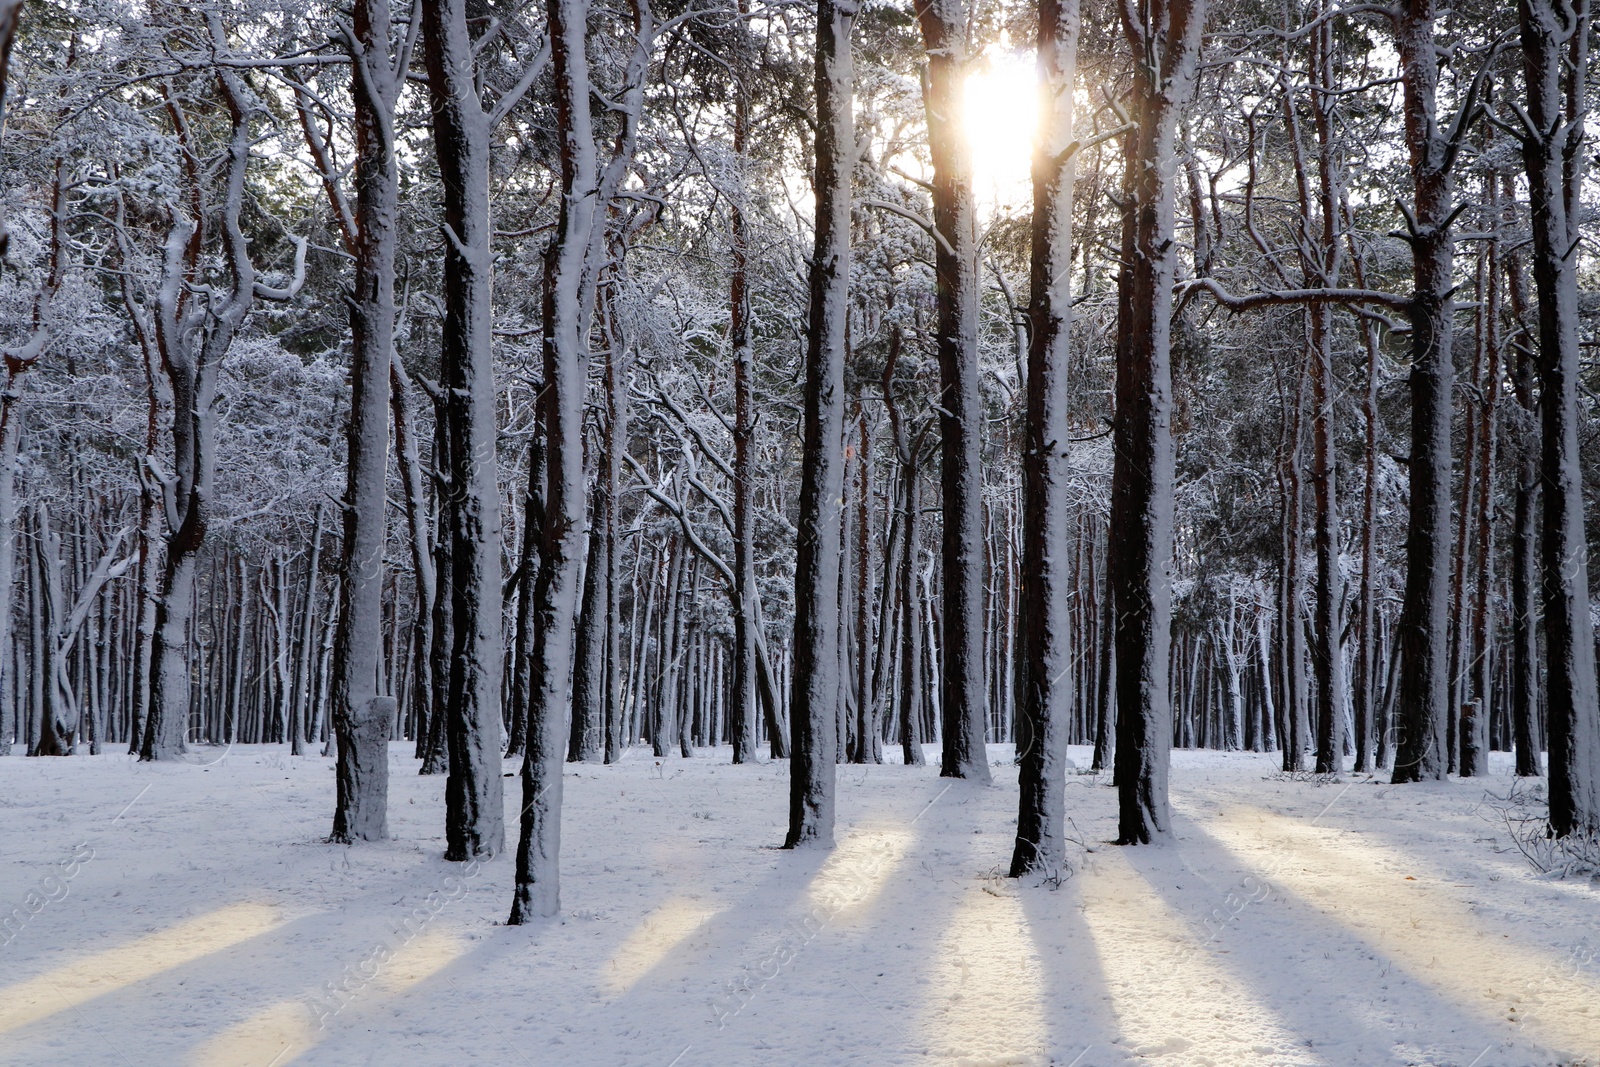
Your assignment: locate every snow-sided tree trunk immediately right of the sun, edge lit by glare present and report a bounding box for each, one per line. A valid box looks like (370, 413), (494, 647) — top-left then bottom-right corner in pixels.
(1011, 0), (1078, 877)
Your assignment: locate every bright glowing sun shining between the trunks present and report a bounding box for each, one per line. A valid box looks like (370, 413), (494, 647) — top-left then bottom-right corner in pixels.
(963, 50), (1038, 210)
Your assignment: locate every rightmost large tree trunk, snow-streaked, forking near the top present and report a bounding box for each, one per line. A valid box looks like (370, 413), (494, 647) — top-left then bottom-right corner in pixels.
(1517, 0), (1600, 837)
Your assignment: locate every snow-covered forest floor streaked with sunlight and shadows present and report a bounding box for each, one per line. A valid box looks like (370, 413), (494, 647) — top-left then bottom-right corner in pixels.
(0, 745), (1600, 1067)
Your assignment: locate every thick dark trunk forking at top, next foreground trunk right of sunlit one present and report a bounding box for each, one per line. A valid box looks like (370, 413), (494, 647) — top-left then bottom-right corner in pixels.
(1109, 0), (1205, 845)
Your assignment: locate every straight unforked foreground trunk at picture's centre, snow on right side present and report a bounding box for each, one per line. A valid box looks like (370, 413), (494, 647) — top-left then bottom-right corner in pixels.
(784, 0), (856, 848)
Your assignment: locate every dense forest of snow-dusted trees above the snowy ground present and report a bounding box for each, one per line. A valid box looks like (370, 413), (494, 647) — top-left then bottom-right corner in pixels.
(0, 0), (1600, 923)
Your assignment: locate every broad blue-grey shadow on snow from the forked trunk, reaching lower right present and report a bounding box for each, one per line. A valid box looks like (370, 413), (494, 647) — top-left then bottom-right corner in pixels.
(1128, 817), (1561, 1067)
